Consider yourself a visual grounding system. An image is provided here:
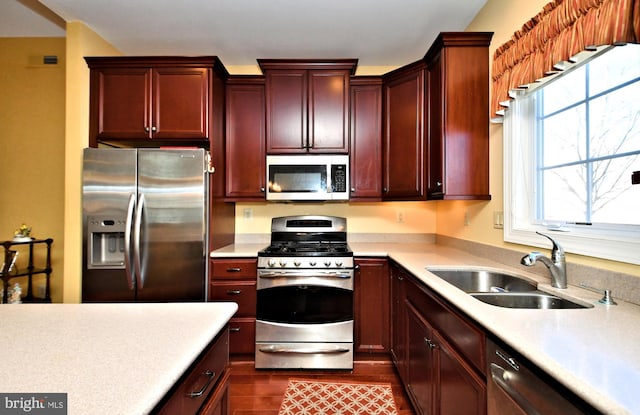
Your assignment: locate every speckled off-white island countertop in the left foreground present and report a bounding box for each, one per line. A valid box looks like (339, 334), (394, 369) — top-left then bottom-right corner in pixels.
(0, 303), (237, 415)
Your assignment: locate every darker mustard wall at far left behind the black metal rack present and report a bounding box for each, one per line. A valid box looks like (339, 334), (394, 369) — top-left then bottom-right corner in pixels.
(0, 38), (66, 302)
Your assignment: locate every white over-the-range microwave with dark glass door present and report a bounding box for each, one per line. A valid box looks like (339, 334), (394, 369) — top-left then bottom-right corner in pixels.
(267, 154), (349, 201)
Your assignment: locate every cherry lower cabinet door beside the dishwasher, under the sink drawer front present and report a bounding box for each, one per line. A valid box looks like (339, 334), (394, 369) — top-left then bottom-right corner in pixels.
(432, 331), (487, 415)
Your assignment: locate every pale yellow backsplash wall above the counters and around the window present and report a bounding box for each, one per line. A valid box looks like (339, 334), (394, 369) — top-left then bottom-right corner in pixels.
(236, 0), (640, 276)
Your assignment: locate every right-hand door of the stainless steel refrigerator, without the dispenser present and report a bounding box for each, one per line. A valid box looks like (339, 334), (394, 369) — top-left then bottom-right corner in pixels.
(133, 149), (207, 301)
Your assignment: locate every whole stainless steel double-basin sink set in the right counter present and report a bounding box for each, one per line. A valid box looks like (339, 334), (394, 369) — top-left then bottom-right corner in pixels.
(427, 268), (593, 309)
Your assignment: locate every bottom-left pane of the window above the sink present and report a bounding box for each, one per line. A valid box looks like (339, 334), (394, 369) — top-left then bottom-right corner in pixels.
(542, 164), (587, 222)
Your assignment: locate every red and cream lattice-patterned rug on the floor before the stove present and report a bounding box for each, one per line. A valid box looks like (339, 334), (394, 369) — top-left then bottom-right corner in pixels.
(278, 379), (398, 415)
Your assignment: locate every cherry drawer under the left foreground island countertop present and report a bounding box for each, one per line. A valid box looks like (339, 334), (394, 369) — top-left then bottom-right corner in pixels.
(159, 330), (229, 415)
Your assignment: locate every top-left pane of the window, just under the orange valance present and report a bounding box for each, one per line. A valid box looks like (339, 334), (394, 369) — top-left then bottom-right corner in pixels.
(541, 66), (586, 115)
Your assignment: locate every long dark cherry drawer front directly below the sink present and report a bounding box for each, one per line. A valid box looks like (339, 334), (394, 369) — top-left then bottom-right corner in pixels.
(407, 281), (486, 374)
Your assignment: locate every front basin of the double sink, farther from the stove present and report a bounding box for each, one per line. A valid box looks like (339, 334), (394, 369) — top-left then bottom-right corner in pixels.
(471, 291), (593, 309)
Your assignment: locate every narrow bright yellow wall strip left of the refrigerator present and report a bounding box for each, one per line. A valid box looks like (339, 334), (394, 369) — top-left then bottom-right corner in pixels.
(64, 22), (121, 303)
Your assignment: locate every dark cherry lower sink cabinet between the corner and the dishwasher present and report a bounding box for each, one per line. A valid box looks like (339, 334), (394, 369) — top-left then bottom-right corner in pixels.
(390, 263), (487, 415)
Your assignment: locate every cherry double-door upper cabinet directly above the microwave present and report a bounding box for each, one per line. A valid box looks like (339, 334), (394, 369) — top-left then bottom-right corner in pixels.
(258, 59), (357, 154)
